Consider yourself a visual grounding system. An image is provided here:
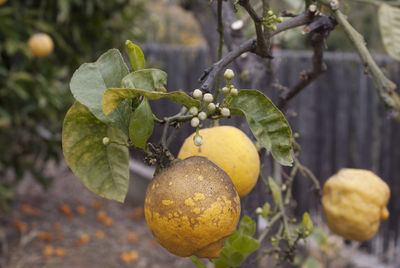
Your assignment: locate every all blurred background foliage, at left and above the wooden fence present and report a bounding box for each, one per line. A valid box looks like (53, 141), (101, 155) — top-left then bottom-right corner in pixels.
(0, 0), (396, 208)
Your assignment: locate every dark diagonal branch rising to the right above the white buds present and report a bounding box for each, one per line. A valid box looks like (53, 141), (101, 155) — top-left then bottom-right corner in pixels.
(199, 11), (314, 92)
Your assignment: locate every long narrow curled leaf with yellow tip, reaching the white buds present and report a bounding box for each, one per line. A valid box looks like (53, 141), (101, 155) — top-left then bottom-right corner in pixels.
(103, 88), (200, 114)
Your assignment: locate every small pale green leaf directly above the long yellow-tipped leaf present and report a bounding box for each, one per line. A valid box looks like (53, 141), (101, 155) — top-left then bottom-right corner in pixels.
(121, 69), (168, 92)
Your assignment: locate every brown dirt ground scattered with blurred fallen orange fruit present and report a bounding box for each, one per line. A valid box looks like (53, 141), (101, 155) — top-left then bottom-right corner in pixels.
(0, 161), (211, 268)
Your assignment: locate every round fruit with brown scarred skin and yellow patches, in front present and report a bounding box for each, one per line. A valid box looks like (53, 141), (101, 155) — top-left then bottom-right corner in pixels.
(144, 157), (240, 258)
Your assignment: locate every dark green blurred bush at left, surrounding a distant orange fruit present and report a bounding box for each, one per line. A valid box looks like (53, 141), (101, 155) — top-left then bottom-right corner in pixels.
(0, 0), (148, 207)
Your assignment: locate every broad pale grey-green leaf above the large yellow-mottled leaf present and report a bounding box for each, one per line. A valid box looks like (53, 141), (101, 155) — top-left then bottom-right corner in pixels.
(70, 49), (131, 134)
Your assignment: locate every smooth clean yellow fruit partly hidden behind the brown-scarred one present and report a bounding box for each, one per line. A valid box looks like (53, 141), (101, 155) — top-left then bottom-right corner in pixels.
(178, 126), (260, 197)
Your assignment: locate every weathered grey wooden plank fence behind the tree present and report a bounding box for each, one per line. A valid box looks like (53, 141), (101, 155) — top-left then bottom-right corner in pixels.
(138, 45), (400, 251)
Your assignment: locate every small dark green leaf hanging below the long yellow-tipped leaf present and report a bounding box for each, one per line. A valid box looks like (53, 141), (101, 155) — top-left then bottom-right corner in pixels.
(129, 98), (154, 149)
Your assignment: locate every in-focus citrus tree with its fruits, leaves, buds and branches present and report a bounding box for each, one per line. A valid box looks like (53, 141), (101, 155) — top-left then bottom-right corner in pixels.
(62, 0), (400, 267)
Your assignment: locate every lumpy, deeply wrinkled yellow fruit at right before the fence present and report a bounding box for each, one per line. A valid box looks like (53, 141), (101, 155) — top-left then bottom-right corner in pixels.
(322, 169), (390, 242)
